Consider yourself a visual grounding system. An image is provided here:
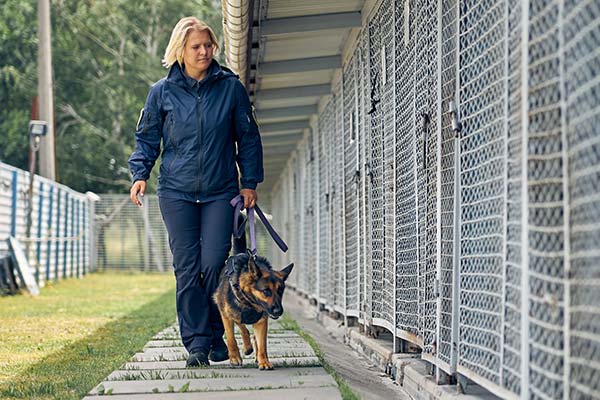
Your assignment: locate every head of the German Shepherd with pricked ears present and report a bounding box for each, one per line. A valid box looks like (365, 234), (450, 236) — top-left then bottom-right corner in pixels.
(240, 257), (294, 319)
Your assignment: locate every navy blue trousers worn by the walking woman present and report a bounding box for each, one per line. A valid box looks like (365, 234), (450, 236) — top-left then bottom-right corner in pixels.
(159, 197), (234, 353)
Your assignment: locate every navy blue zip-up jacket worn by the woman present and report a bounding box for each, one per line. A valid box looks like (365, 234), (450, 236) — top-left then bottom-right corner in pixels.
(129, 60), (263, 201)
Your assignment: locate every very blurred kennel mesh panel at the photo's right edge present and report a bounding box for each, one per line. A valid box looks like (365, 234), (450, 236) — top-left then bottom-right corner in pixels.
(563, 1), (600, 399)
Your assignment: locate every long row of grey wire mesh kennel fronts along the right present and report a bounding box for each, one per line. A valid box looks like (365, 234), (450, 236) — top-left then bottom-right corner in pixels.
(271, 0), (600, 399)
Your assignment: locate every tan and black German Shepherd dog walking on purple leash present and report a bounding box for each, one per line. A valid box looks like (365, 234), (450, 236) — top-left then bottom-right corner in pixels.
(213, 253), (294, 370)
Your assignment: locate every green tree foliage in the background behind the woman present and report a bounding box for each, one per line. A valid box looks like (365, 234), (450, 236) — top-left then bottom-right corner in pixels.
(0, 0), (222, 193)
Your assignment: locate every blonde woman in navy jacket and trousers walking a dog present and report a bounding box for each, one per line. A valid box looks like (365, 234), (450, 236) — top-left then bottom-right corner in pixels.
(129, 17), (263, 367)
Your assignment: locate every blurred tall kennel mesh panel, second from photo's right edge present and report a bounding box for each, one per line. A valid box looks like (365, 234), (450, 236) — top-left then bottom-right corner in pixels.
(527, 1), (566, 398)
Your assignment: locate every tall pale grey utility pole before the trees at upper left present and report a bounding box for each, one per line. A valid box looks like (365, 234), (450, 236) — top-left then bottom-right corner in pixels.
(38, 0), (56, 181)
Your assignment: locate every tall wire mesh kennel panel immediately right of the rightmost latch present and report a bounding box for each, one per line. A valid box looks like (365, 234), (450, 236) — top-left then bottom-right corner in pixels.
(459, 0), (506, 384)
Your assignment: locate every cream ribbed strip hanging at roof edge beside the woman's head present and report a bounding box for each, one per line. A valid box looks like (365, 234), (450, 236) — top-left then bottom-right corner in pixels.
(221, 0), (253, 87)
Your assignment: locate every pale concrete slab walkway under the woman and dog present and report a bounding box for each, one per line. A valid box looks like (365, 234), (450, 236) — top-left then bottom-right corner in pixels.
(84, 320), (341, 400)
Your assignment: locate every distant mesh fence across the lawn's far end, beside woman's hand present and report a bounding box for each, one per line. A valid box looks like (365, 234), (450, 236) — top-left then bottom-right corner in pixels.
(94, 194), (173, 271)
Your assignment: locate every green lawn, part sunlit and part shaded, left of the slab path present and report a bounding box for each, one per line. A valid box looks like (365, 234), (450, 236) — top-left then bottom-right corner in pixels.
(0, 273), (176, 399)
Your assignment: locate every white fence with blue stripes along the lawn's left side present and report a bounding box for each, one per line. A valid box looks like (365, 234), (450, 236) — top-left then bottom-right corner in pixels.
(0, 159), (94, 286)
